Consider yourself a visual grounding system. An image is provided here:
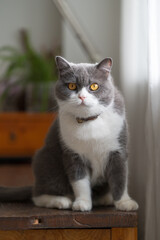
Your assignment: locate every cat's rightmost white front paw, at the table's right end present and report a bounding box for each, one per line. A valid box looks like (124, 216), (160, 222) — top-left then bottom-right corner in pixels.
(115, 199), (138, 211)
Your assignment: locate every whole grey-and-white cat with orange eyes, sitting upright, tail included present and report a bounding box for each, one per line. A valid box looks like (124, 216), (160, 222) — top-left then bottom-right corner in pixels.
(0, 56), (138, 211)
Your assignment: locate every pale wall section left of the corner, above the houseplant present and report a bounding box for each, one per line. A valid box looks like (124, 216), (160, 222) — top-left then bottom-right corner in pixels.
(0, 0), (61, 51)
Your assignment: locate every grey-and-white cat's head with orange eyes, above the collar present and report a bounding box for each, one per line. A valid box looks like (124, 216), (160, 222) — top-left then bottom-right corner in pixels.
(55, 56), (114, 117)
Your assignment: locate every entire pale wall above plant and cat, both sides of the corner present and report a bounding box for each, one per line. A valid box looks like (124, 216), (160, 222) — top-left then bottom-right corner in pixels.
(0, 0), (121, 83)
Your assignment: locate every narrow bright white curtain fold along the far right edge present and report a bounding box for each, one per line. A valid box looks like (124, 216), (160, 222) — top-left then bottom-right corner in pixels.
(145, 0), (160, 240)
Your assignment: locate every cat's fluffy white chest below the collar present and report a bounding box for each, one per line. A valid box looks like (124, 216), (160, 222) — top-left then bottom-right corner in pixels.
(60, 112), (123, 185)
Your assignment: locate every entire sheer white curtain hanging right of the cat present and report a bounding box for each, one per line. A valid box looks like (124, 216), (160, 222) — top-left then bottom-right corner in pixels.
(120, 0), (160, 240)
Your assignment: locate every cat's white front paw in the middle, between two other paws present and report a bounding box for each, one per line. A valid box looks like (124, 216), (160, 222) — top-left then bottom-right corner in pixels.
(72, 199), (92, 212)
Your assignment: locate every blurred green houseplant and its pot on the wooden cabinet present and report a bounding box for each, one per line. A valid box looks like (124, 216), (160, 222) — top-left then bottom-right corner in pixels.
(0, 30), (57, 112)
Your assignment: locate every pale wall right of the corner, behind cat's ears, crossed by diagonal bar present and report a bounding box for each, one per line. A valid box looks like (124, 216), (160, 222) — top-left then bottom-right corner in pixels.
(62, 0), (121, 82)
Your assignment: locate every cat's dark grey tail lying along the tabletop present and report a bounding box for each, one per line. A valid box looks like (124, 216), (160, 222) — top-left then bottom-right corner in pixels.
(0, 186), (33, 202)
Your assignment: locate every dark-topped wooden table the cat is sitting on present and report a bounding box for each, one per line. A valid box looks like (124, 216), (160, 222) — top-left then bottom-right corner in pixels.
(0, 203), (137, 240)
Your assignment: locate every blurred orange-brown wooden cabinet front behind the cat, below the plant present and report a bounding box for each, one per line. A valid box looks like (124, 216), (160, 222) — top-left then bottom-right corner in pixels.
(0, 113), (56, 157)
